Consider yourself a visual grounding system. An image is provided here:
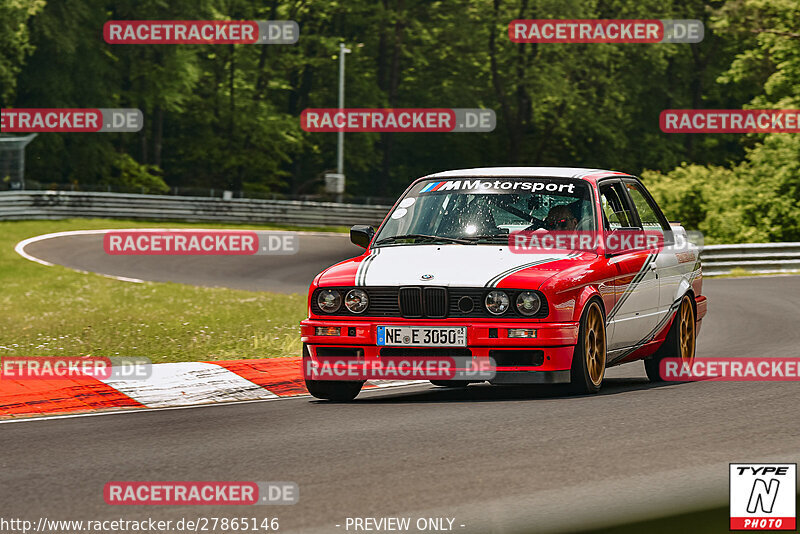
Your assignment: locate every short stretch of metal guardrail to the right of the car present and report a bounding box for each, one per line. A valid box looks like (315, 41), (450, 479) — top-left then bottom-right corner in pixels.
(700, 243), (800, 275)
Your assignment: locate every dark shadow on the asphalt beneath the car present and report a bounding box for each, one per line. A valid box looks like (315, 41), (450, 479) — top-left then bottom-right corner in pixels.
(318, 378), (692, 404)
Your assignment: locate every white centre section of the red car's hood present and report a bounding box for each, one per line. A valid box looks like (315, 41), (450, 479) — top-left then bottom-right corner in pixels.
(356, 245), (577, 287)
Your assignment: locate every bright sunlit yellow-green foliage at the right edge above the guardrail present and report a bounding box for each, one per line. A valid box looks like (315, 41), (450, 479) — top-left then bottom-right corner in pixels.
(645, 0), (800, 243)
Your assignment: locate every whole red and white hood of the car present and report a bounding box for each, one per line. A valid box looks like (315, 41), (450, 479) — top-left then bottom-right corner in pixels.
(317, 245), (595, 288)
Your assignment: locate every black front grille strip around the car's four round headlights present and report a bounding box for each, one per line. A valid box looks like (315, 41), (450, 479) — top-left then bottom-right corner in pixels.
(311, 286), (549, 319)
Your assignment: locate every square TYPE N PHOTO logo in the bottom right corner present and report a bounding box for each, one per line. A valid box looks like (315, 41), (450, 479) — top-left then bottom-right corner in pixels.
(730, 464), (797, 531)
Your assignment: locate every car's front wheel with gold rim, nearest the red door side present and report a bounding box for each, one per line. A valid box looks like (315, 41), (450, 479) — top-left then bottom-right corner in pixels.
(570, 300), (606, 393)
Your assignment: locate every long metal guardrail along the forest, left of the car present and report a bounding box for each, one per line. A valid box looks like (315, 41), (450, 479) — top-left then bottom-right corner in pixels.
(0, 191), (391, 226)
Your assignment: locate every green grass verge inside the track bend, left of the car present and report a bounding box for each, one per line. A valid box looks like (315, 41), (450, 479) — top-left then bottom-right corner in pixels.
(0, 219), (340, 363)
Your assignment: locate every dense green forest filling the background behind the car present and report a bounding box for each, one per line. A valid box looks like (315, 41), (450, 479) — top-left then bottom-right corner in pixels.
(0, 0), (800, 241)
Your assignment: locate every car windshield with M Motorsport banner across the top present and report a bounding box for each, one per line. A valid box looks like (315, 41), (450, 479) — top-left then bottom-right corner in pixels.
(373, 177), (595, 246)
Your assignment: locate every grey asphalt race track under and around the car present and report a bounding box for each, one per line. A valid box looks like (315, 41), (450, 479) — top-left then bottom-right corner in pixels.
(6, 232), (800, 533)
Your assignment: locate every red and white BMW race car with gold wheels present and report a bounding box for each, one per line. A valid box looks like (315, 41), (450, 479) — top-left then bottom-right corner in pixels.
(301, 167), (707, 400)
